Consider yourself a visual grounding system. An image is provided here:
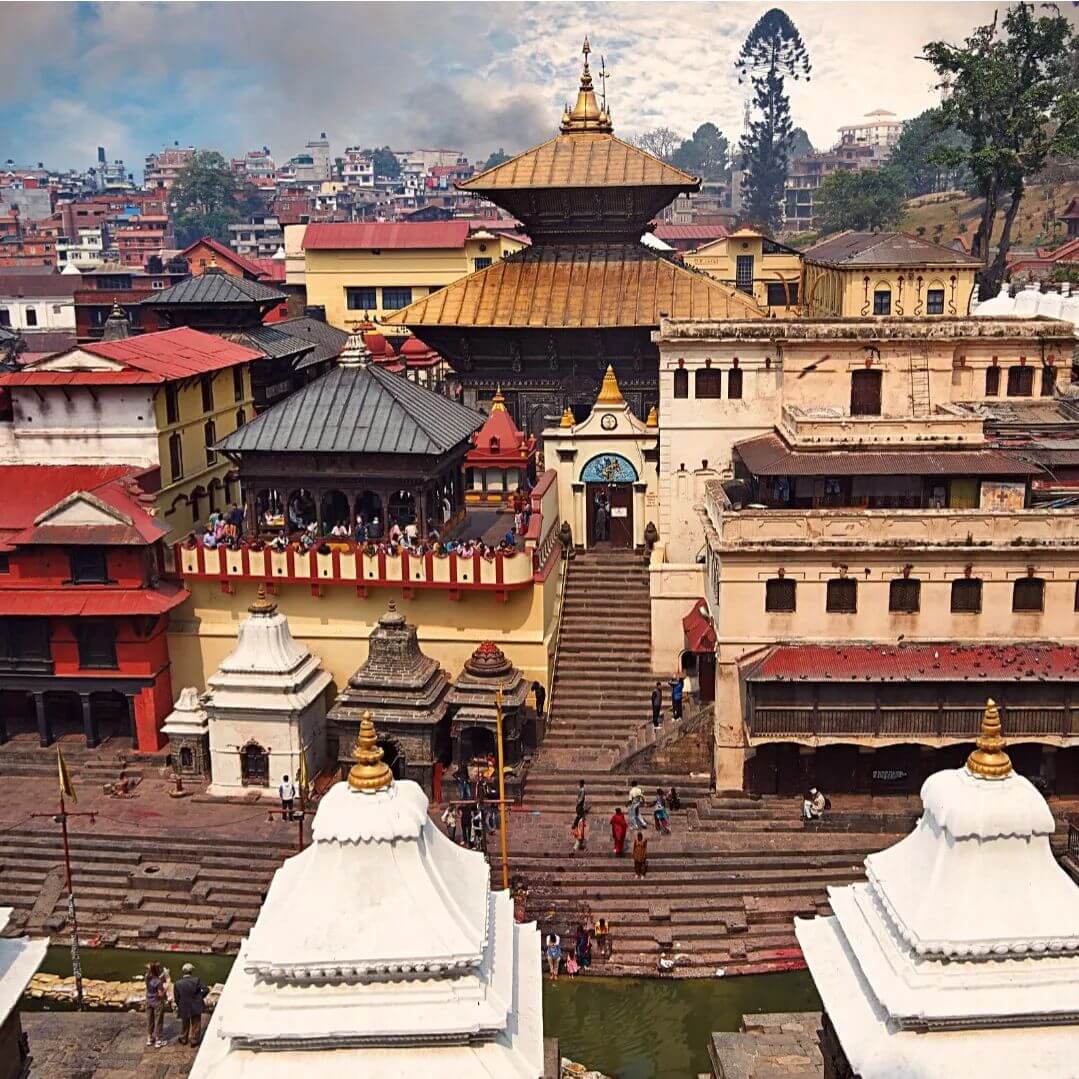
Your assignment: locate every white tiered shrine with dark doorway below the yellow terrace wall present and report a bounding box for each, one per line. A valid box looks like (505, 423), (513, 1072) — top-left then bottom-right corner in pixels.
(203, 585), (331, 797)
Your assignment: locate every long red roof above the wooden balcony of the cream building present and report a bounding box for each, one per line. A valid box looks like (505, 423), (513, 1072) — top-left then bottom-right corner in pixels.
(746, 644), (1079, 682)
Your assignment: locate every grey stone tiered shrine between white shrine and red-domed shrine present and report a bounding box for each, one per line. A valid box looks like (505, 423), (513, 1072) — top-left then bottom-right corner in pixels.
(328, 602), (452, 797)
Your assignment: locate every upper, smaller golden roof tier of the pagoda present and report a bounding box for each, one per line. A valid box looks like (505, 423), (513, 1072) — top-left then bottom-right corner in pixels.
(456, 132), (700, 192)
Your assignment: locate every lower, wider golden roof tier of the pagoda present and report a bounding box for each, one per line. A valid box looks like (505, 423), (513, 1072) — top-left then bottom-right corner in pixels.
(385, 244), (766, 329)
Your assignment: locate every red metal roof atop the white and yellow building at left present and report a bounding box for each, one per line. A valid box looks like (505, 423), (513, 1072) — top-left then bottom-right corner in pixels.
(0, 326), (262, 386)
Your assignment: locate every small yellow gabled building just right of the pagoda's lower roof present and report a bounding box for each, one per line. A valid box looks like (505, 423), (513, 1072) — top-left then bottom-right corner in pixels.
(682, 228), (802, 318)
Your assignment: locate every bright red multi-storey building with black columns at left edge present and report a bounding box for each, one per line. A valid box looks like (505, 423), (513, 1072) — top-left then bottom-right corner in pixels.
(0, 465), (188, 752)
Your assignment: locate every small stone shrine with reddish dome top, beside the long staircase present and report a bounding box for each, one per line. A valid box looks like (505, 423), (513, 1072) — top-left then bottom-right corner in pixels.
(448, 641), (537, 766)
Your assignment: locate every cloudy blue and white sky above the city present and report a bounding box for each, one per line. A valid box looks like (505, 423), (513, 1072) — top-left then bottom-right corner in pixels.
(0, 0), (1061, 172)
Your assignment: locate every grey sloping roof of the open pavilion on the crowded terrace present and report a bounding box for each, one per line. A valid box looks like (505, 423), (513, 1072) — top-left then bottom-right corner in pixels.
(215, 366), (484, 455)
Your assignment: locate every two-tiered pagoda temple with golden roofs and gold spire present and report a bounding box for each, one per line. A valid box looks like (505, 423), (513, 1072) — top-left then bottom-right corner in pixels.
(386, 40), (766, 434)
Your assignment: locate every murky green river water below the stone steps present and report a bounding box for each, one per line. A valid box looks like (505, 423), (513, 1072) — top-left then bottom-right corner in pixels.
(41, 945), (820, 1079)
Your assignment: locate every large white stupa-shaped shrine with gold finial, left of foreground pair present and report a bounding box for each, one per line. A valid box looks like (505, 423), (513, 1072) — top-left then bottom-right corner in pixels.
(191, 713), (544, 1079)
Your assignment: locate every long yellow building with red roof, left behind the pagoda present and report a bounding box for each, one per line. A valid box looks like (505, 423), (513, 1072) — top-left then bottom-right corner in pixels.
(302, 220), (525, 333)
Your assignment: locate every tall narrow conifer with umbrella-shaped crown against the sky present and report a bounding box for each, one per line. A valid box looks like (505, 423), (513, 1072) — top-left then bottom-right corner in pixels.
(735, 8), (810, 229)
